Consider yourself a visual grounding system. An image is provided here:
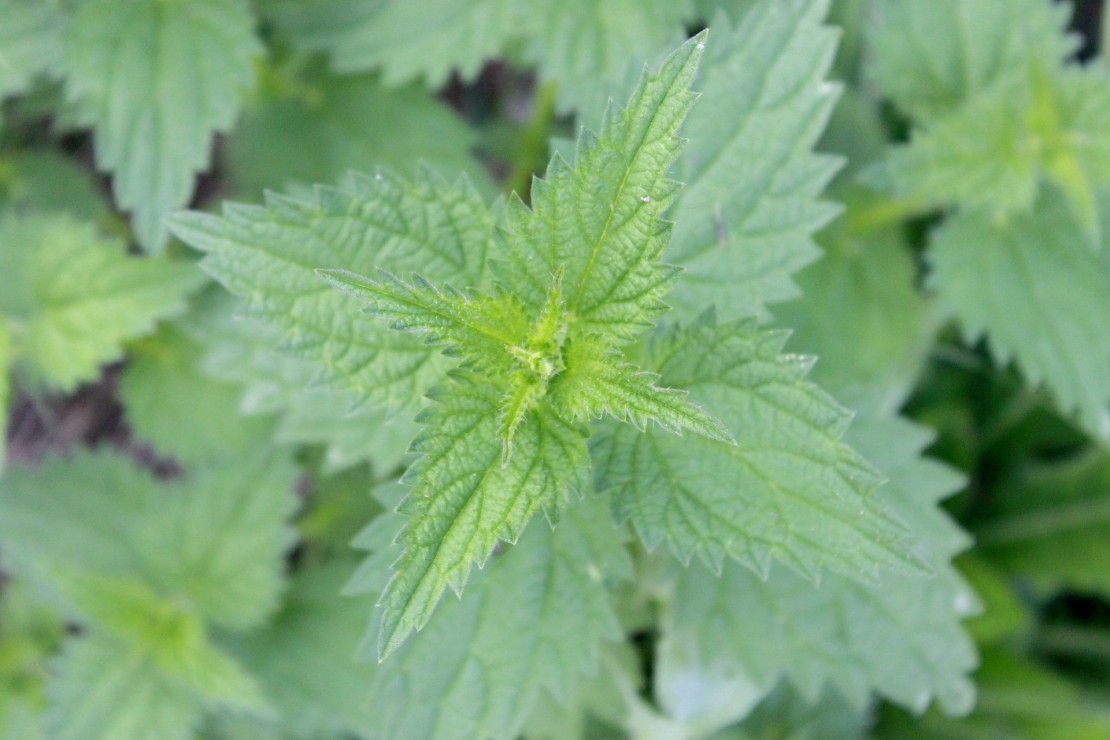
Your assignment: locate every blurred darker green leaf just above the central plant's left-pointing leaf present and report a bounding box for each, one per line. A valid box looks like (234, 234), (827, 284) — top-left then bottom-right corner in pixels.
(226, 63), (493, 199)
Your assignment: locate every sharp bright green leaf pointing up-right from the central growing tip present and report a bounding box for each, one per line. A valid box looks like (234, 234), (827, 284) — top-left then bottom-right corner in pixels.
(495, 28), (706, 341)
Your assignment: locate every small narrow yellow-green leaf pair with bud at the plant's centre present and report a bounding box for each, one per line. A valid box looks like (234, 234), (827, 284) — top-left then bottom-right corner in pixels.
(317, 270), (736, 466)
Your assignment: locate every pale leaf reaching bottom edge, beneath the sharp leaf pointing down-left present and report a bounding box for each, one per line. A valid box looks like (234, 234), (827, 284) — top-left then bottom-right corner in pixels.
(352, 492), (630, 738)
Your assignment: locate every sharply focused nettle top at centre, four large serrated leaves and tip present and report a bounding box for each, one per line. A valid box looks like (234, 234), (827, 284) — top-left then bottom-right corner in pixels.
(171, 26), (929, 658)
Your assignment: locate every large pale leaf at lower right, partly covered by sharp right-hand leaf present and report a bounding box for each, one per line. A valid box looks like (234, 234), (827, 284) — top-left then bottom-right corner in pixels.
(658, 410), (976, 713)
